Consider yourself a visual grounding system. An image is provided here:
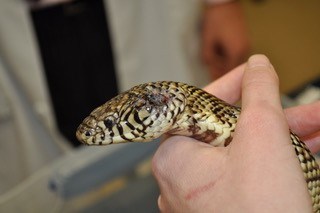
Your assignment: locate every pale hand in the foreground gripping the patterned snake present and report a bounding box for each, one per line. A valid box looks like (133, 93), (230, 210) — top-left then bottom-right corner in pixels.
(152, 56), (312, 212)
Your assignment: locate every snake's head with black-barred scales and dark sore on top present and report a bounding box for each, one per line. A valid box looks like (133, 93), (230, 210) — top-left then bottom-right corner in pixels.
(76, 82), (185, 145)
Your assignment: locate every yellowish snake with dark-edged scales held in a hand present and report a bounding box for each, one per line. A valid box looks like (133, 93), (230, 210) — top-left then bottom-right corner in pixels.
(76, 81), (320, 212)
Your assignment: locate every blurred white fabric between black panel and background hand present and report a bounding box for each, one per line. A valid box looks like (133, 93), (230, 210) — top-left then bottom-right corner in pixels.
(106, 0), (208, 90)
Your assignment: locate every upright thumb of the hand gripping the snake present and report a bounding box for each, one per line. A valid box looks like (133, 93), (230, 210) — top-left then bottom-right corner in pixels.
(237, 55), (290, 148)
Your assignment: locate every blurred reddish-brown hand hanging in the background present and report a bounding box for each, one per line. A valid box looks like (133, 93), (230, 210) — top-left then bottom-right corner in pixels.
(201, 1), (249, 79)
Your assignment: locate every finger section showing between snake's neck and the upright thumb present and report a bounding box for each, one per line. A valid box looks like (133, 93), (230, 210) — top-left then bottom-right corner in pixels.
(204, 64), (245, 104)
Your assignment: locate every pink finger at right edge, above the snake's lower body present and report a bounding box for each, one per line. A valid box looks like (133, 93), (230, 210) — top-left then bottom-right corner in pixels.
(285, 101), (320, 137)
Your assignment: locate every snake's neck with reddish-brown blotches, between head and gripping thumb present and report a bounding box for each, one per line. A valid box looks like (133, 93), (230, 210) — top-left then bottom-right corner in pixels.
(168, 86), (240, 146)
